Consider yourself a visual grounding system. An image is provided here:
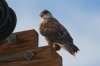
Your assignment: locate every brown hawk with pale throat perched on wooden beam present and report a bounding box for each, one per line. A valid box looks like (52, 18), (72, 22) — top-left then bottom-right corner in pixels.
(39, 10), (79, 55)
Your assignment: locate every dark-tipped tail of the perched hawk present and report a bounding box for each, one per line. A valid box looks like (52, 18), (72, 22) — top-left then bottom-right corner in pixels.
(65, 44), (79, 56)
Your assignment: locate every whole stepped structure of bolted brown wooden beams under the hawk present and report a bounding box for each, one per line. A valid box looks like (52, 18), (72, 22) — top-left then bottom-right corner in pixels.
(0, 30), (62, 66)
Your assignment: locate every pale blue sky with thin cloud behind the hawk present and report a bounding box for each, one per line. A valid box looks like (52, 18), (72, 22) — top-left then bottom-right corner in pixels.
(6, 0), (100, 66)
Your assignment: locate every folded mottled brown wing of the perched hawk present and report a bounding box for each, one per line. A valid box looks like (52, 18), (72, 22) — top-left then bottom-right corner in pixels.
(40, 18), (73, 44)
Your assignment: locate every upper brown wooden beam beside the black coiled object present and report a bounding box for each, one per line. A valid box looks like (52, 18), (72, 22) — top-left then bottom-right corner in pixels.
(0, 30), (38, 54)
